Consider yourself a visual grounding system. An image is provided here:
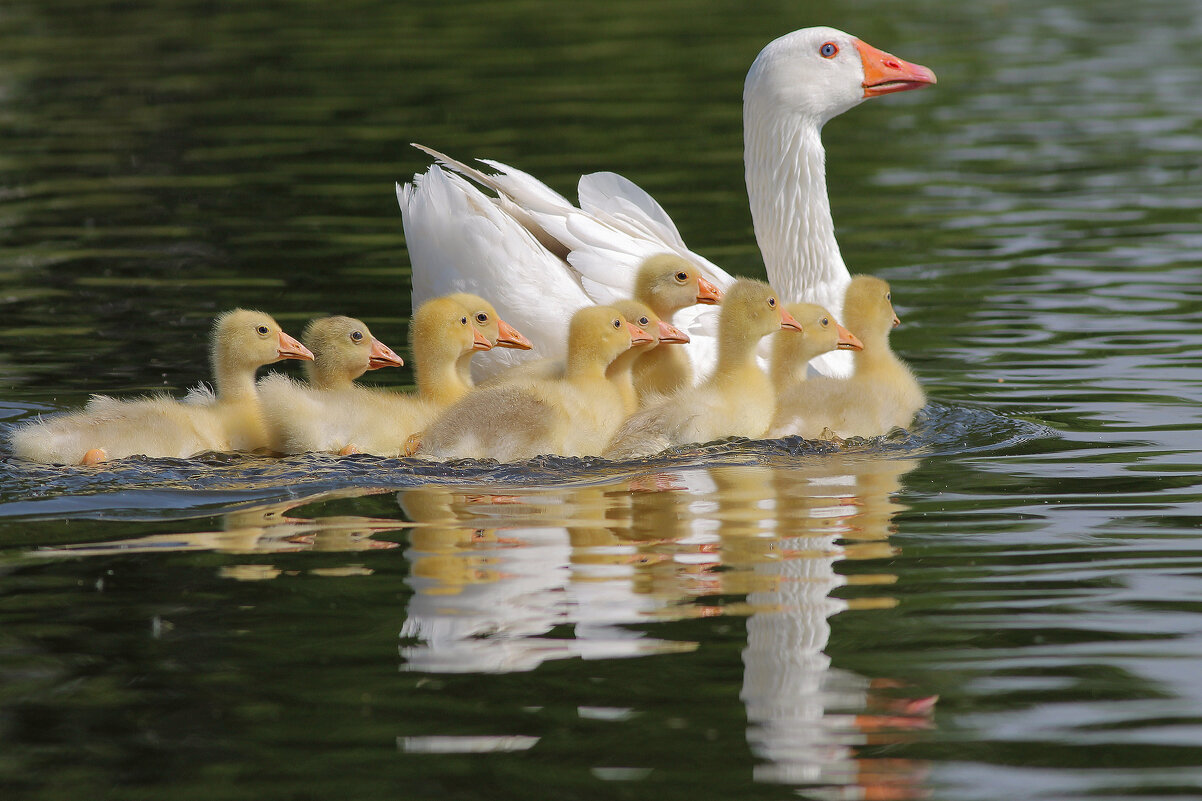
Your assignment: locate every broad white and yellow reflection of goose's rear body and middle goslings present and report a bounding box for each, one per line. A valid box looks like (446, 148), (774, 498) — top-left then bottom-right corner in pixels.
(398, 481), (695, 672)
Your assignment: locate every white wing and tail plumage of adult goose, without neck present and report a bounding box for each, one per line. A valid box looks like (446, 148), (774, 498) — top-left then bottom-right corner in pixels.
(397, 144), (750, 378)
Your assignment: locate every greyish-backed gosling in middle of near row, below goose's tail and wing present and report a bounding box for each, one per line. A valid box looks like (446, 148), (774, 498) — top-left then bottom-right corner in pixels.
(418, 307), (650, 462)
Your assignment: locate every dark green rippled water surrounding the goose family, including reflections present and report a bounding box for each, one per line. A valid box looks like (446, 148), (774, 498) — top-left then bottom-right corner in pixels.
(0, 0), (1202, 801)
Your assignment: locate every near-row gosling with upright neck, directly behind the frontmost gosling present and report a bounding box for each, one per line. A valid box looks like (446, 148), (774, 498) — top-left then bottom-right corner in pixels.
(605, 279), (799, 459)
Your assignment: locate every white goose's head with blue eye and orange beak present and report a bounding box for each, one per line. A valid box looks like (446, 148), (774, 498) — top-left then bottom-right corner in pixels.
(743, 28), (935, 126)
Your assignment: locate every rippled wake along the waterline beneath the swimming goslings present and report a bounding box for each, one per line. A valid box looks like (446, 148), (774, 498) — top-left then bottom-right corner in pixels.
(0, 403), (1057, 520)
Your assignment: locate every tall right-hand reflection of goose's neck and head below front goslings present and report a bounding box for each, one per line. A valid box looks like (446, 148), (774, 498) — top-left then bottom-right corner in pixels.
(710, 455), (934, 799)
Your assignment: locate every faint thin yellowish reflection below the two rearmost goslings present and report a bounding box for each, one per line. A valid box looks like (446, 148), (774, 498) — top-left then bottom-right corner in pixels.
(34, 491), (405, 567)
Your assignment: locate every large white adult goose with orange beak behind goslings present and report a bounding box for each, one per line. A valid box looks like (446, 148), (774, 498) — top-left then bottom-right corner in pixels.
(397, 28), (935, 375)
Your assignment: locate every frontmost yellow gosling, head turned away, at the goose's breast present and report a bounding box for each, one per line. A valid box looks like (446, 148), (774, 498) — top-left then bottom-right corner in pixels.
(769, 275), (926, 439)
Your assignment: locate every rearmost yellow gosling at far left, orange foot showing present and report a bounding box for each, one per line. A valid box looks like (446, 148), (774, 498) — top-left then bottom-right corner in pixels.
(12, 309), (313, 464)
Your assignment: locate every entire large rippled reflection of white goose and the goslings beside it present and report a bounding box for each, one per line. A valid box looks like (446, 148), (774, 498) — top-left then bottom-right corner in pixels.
(399, 451), (935, 799)
